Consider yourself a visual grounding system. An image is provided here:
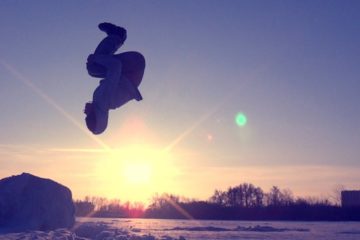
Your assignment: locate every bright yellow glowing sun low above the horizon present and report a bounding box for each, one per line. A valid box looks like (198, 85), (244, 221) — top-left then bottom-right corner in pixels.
(96, 145), (179, 203)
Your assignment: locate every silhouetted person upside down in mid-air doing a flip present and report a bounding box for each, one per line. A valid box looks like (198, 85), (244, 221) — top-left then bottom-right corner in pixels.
(84, 23), (145, 134)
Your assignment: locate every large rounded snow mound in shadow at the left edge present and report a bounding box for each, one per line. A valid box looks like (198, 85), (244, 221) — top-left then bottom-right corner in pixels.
(0, 173), (75, 232)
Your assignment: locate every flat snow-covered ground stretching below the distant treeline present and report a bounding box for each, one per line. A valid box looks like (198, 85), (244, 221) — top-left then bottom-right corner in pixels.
(0, 218), (360, 240)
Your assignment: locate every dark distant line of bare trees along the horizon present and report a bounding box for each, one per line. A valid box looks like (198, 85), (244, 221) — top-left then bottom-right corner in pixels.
(75, 183), (360, 221)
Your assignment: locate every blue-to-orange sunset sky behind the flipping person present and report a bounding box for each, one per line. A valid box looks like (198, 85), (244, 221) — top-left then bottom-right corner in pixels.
(0, 0), (360, 201)
